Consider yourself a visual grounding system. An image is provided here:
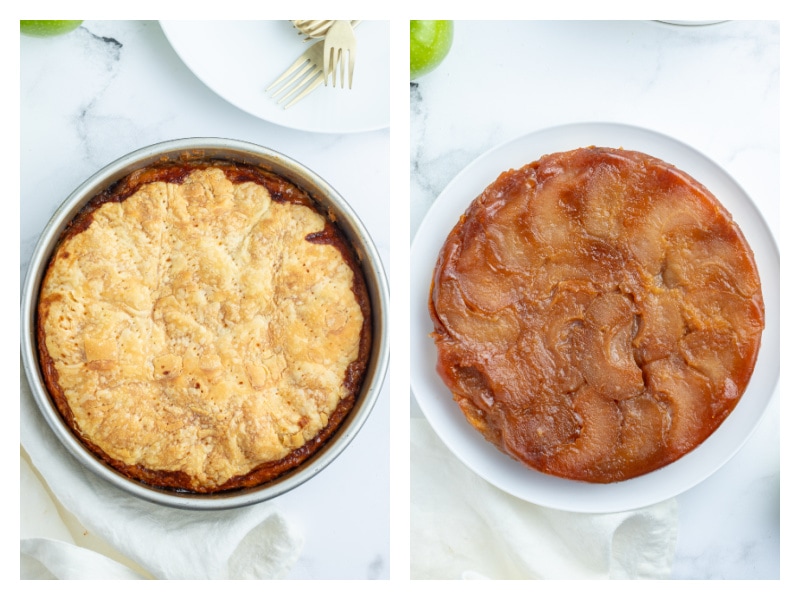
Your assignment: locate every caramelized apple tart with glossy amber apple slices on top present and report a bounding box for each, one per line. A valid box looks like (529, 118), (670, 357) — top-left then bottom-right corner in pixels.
(429, 147), (764, 483)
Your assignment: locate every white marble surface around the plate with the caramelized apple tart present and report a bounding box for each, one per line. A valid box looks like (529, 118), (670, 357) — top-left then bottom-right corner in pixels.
(410, 21), (780, 579)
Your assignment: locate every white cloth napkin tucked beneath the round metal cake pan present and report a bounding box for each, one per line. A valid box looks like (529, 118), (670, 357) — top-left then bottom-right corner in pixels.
(20, 368), (303, 579)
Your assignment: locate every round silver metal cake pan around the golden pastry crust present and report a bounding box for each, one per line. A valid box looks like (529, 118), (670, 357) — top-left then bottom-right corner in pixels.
(21, 138), (389, 510)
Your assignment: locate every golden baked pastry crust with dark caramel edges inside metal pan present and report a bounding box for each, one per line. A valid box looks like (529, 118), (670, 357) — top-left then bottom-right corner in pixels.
(37, 162), (371, 493)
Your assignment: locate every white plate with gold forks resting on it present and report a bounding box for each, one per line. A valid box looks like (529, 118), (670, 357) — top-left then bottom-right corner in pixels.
(160, 21), (389, 133)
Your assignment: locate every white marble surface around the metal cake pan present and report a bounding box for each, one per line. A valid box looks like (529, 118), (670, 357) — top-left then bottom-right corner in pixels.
(20, 21), (389, 579)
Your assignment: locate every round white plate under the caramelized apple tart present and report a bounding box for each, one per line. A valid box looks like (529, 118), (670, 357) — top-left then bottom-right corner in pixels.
(410, 123), (779, 513)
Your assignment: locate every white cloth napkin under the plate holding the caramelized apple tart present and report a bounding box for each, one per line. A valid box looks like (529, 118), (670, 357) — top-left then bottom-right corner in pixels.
(411, 417), (678, 579)
